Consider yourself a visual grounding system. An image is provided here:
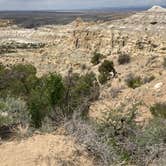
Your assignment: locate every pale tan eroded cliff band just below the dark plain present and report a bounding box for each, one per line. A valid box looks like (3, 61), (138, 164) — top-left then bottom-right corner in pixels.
(0, 7), (166, 66)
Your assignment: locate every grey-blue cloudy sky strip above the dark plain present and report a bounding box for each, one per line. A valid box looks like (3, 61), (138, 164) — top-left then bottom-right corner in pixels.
(0, 0), (166, 10)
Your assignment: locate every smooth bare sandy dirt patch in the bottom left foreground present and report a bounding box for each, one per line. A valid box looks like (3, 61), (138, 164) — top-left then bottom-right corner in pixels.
(0, 134), (94, 166)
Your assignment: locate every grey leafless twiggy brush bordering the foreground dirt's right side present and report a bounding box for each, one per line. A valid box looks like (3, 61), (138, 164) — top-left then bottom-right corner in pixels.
(65, 116), (111, 166)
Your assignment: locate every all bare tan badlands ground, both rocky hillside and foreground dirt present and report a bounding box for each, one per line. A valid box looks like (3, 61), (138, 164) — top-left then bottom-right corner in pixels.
(0, 6), (166, 166)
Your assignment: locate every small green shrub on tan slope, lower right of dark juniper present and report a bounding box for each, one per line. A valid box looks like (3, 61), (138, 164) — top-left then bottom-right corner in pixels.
(125, 74), (143, 89)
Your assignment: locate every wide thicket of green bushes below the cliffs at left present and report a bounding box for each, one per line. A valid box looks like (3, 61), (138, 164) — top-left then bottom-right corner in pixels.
(0, 64), (99, 128)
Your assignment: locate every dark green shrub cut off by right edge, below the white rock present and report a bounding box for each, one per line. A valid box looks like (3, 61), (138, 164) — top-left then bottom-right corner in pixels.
(150, 103), (166, 119)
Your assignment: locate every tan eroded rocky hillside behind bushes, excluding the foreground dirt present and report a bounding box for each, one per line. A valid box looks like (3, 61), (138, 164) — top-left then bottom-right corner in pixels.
(0, 8), (166, 121)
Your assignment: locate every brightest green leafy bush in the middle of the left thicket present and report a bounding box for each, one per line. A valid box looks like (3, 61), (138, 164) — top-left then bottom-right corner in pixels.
(28, 73), (64, 128)
